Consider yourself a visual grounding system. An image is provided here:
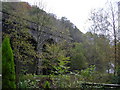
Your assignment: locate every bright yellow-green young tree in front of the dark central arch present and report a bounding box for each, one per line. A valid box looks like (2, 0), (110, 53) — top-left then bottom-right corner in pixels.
(42, 44), (70, 74)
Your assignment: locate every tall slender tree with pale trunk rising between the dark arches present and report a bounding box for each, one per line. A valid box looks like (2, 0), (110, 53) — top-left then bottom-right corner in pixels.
(30, 2), (51, 74)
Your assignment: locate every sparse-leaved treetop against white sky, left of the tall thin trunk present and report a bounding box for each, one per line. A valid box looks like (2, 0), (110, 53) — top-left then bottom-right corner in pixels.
(89, 8), (110, 36)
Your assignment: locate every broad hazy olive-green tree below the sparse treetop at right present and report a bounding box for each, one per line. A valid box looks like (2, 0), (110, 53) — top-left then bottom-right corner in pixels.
(82, 32), (112, 72)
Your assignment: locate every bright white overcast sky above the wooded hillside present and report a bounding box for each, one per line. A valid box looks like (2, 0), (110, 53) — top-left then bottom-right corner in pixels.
(21, 0), (119, 33)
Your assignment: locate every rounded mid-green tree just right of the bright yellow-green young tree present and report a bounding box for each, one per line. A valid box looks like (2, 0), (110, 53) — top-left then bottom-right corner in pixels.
(71, 43), (87, 69)
